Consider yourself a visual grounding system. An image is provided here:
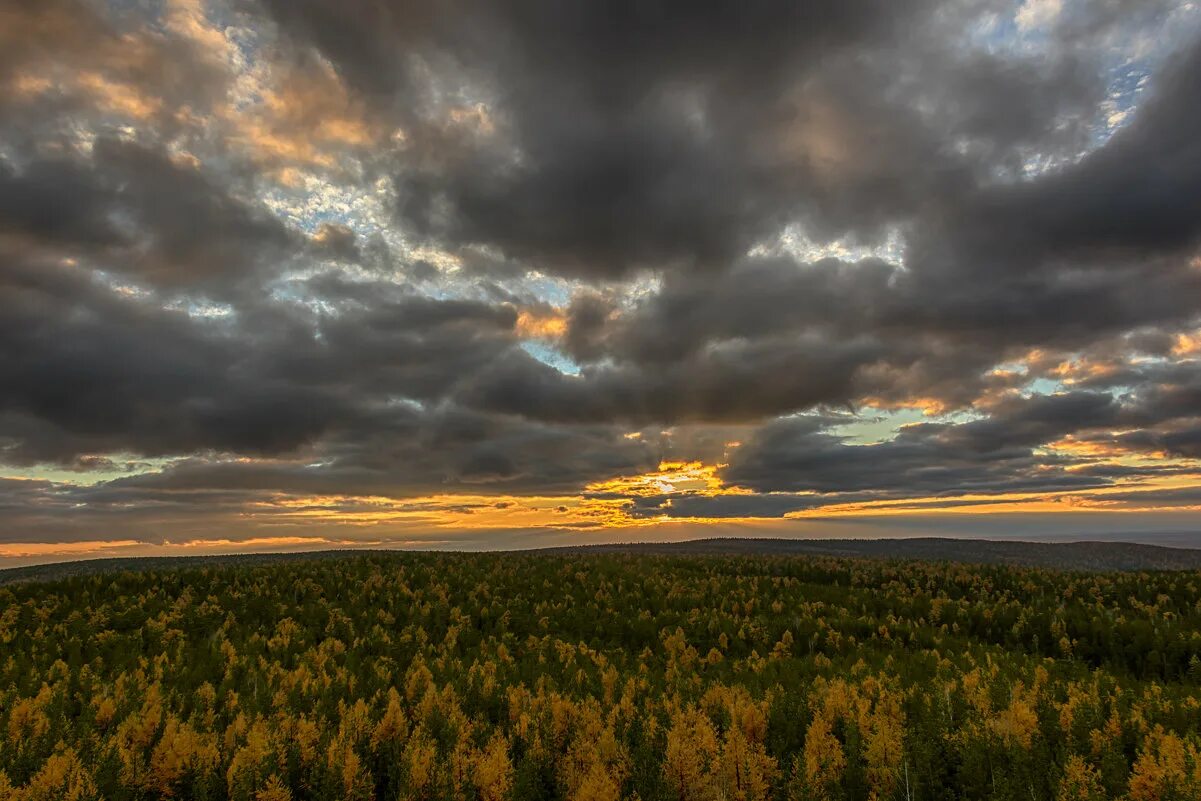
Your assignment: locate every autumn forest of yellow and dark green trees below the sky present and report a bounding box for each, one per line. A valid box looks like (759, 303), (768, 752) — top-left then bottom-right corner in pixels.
(0, 554), (1201, 801)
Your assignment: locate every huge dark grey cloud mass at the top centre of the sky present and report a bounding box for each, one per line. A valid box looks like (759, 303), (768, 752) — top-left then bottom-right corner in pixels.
(258, 1), (1128, 279)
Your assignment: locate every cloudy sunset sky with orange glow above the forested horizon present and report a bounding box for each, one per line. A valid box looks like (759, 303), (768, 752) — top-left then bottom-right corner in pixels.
(0, 0), (1201, 564)
